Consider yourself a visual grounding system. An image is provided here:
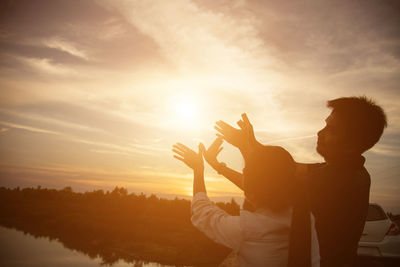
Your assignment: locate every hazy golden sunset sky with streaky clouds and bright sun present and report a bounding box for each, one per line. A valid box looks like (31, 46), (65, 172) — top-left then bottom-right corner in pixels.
(0, 0), (400, 213)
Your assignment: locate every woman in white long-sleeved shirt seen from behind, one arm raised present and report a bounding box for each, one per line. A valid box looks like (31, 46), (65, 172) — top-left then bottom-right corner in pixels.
(173, 143), (319, 267)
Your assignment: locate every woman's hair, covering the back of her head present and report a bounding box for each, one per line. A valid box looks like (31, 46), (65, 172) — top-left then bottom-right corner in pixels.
(243, 146), (295, 211)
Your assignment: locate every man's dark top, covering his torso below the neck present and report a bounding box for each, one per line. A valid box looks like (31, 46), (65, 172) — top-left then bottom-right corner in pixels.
(309, 156), (371, 267)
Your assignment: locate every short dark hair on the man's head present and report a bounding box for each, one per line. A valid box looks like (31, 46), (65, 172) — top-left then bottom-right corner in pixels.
(327, 96), (387, 153)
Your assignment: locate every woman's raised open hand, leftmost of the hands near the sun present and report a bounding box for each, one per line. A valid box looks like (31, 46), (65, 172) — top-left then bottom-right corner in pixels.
(172, 143), (204, 171)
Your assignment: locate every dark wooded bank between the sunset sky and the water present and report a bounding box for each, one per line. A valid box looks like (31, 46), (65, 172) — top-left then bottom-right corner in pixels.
(0, 186), (240, 266)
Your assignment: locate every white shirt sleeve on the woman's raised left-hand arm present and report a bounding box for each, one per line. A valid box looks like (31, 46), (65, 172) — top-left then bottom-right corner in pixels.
(191, 192), (242, 252)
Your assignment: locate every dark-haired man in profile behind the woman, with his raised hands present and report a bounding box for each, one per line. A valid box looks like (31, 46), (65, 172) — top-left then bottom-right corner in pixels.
(205, 97), (387, 267)
